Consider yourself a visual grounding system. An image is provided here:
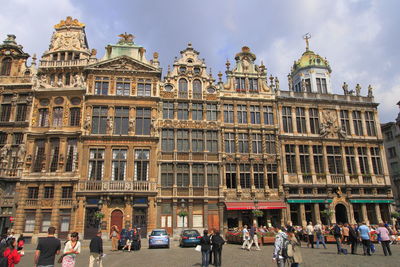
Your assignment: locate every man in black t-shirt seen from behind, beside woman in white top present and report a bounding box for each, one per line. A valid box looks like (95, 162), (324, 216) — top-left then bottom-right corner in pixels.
(34, 226), (61, 267)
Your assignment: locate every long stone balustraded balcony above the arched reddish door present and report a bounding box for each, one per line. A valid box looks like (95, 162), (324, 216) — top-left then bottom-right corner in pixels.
(78, 181), (157, 193)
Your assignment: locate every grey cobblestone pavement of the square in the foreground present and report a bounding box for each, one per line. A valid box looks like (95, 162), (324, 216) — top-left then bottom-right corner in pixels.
(17, 240), (400, 267)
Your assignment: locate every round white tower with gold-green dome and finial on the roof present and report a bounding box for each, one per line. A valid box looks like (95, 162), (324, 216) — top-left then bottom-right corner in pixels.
(288, 34), (332, 94)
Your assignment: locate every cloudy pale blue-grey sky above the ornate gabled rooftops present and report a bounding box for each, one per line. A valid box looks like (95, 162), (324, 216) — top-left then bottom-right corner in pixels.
(0, 0), (400, 123)
